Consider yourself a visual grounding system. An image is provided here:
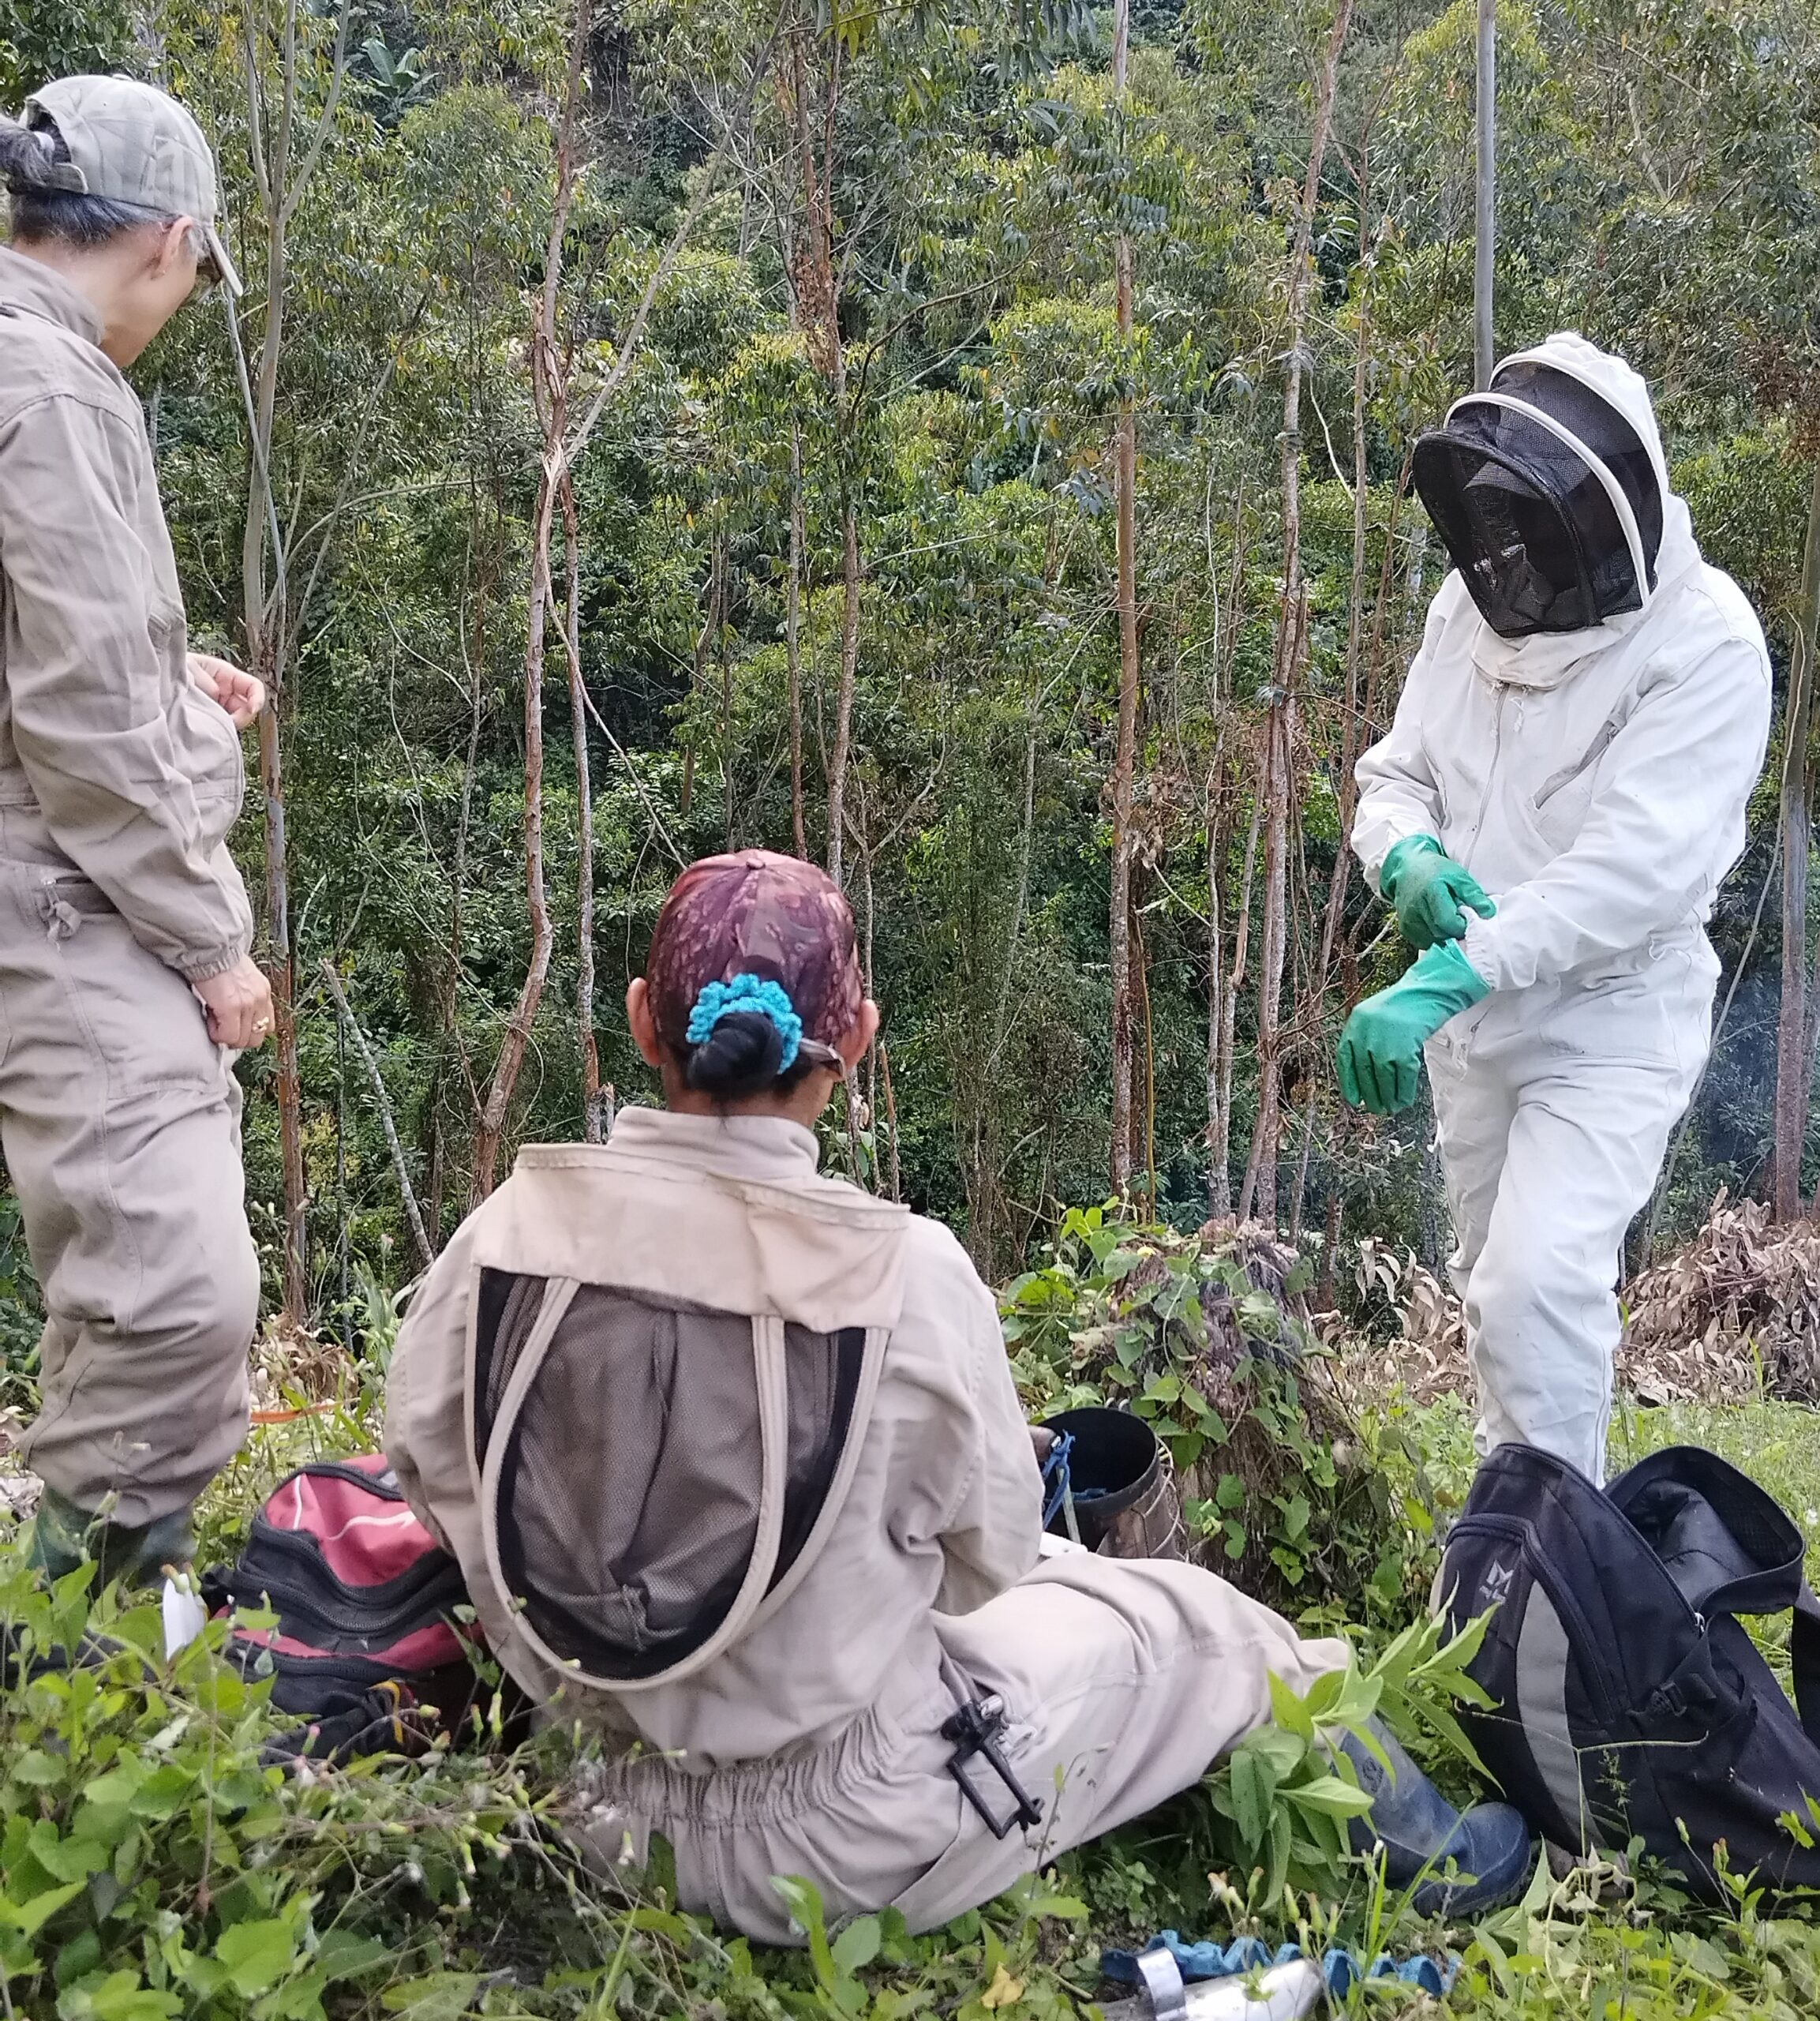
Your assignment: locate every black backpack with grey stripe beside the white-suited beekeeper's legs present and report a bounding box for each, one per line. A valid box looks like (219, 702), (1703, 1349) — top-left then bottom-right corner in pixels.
(1436, 1445), (1820, 1904)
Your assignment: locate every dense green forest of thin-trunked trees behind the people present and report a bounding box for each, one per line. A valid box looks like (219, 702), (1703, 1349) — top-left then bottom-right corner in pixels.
(0, 0), (1820, 1324)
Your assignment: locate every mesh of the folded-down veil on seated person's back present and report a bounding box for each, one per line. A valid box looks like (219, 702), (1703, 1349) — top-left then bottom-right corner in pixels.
(482, 1285), (864, 1679)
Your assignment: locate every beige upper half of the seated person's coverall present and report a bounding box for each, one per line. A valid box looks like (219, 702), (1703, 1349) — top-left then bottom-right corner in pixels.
(386, 1108), (1040, 1764)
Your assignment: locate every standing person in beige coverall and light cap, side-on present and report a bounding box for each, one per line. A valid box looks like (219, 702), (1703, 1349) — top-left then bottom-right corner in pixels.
(0, 77), (273, 1577)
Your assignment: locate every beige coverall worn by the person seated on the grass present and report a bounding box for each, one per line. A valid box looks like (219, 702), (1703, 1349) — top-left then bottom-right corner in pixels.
(386, 1109), (1346, 1942)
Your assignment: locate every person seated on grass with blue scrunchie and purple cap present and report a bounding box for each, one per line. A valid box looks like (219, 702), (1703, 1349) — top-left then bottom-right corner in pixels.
(386, 851), (1529, 1942)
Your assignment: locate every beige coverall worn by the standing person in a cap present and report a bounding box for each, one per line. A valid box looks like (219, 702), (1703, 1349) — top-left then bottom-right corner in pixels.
(0, 249), (259, 1524)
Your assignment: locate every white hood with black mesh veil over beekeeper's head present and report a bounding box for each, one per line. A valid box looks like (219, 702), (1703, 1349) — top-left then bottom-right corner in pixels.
(1414, 336), (1668, 639)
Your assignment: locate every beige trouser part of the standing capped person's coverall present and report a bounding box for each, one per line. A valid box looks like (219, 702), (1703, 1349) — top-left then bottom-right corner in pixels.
(0, 859), (259, 1528)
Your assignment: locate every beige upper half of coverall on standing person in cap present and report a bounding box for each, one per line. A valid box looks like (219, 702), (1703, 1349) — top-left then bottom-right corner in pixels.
(0, 246), (253, 982)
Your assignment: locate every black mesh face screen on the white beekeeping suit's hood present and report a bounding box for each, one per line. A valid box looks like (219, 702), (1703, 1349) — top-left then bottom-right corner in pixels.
(1414, 402), (1642, 639)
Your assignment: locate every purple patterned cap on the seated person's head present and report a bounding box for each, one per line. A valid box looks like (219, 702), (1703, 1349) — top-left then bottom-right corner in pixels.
(644, 849), (864, 1055)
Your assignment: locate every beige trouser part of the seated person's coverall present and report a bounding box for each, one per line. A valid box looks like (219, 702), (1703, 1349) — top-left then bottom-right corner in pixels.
(596, 1556), (1347, 1942)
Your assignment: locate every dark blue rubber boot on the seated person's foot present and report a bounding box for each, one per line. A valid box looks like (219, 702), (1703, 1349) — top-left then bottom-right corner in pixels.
(1339, 1720), (1535, 1920)
